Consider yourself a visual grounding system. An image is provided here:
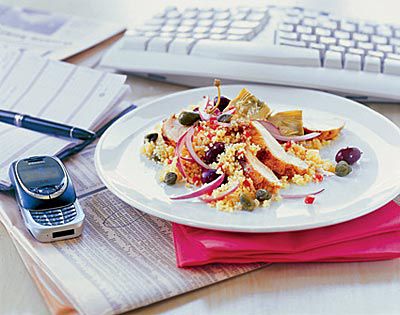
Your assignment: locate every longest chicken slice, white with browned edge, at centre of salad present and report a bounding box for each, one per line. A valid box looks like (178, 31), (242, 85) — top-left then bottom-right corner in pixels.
(251, 121), (308, 177)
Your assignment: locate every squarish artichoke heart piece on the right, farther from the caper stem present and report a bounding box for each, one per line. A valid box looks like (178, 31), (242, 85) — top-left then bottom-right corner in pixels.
(268, 110), (304, 136)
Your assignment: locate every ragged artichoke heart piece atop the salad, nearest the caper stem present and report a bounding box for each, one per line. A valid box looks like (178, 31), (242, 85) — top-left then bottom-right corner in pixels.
(227, 89), (271, 119)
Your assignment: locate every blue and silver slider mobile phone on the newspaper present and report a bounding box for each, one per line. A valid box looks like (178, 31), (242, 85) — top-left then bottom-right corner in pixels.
(9, 156), (85, 242)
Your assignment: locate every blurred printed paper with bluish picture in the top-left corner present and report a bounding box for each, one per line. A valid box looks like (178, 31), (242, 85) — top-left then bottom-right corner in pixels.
(0, 4), (125, 60)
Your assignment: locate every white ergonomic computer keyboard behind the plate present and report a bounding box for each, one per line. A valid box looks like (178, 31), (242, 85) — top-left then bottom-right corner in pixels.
(102, 6), (400, 101)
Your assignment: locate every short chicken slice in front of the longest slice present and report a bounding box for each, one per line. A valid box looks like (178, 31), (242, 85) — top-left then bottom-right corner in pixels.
(242, 150), (282, 194)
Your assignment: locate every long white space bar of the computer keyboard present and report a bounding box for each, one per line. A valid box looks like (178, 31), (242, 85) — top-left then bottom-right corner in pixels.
(190, 40), (321, 67)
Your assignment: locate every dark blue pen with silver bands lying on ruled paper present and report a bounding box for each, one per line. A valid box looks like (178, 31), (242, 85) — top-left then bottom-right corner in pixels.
(0, 110), (96, 140)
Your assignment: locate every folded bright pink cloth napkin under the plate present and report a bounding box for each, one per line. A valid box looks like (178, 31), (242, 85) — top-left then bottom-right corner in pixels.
(173, 201), (400, 267)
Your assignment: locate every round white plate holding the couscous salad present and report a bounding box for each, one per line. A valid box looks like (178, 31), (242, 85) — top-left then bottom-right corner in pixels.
(95, 85), (400, 232)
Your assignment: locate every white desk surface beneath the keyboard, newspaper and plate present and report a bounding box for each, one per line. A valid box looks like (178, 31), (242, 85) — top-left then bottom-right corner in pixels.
(0, 0), (400, 315)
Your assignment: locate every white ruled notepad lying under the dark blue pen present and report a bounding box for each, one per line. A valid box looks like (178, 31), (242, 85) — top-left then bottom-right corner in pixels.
(0, 50), (128, 185)
